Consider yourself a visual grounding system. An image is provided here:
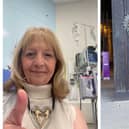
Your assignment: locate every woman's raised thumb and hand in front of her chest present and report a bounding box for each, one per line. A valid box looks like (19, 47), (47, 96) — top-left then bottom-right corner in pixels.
(4, 89), (28, 129)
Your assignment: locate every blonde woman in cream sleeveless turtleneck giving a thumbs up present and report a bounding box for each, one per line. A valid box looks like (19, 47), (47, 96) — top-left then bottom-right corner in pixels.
(4, 28), (87, 129)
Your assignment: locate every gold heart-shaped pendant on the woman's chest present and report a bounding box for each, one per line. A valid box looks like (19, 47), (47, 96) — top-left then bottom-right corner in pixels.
(31, 106), (51, 129)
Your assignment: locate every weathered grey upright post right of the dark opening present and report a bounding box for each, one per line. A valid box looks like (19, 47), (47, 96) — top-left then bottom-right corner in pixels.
(112, 0), (129, 93)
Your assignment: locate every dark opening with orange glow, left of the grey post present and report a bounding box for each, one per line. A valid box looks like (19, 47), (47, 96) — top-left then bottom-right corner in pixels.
(101, 0), (114, 79)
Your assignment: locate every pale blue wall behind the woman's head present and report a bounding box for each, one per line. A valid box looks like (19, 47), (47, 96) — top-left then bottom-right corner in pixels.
(3, 0), (56, 69)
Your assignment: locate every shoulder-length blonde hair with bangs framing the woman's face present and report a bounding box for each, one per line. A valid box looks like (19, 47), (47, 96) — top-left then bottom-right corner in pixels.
(4, 27), (69, 99)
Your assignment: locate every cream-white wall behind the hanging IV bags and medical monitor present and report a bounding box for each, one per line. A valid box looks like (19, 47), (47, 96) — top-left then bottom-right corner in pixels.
(56, 0), (97, 79)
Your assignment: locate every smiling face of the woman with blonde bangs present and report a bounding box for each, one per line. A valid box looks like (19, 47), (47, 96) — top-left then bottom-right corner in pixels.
(22, 41), (56, 85)
